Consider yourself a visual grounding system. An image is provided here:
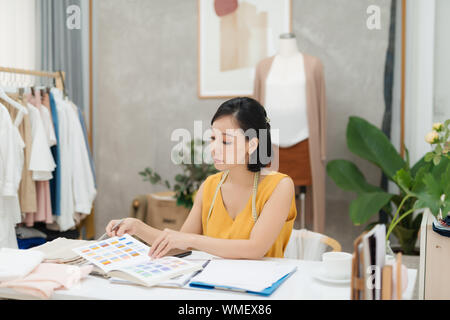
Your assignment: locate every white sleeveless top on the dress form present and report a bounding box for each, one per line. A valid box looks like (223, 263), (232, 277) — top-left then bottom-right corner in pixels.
(264, 53), (309, 148)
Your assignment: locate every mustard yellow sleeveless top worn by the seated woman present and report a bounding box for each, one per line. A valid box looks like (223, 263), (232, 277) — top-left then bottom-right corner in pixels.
(202, 171), (297, 258)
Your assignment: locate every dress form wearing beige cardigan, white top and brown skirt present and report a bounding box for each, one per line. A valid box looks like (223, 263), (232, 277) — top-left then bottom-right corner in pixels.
(253, 34), (327, 233)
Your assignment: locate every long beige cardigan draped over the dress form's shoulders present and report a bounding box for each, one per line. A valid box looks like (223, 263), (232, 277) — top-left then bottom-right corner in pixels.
(253, 54), (327, 233)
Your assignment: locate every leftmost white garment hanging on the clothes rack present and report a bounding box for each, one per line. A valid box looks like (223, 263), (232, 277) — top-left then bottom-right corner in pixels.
(0, 104), (25, 249)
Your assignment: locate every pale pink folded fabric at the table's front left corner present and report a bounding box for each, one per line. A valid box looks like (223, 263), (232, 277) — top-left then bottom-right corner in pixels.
(0, 263), (93, 299)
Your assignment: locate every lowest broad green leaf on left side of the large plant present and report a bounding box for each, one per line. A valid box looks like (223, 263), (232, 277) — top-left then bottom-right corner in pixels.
(350, 192), (394, 225)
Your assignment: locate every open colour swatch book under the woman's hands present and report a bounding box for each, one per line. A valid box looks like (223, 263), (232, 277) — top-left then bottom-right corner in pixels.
(72, 234), (202, 286)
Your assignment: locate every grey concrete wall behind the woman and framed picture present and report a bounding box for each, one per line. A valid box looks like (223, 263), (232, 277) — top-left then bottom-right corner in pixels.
(94, 0), (390, 238)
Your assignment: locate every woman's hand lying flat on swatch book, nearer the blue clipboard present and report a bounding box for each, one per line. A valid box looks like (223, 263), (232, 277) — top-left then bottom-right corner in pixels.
(148, 228), (189, 259)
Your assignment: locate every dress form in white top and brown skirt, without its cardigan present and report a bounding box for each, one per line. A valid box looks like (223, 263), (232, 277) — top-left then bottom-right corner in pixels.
(265, 33), (312, 228)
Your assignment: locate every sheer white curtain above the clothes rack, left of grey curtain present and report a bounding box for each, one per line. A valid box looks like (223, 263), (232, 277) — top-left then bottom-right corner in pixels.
(0, 0), (38, 85)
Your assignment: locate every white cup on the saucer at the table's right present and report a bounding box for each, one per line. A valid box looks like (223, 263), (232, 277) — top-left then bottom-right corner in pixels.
(322, 252), (353, 280)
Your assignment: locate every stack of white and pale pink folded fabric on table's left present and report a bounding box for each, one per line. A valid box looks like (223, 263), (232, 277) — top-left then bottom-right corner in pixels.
(0, 248), (92, 299)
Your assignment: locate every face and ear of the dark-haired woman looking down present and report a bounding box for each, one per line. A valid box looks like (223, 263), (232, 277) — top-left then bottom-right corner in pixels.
(210, 115), (258, 171)
